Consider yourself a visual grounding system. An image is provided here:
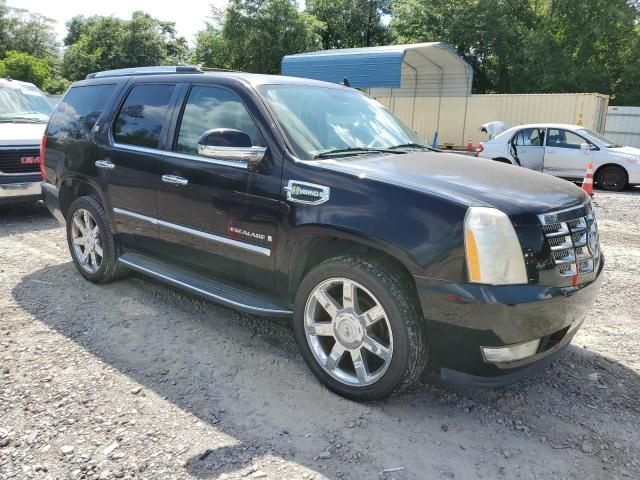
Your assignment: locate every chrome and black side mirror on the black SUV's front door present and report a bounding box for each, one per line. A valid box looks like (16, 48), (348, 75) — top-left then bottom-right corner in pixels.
(198, 128), (267, 170)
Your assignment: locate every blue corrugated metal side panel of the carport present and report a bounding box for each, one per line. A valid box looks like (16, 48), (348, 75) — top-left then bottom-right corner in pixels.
(281, 47), (404, 88)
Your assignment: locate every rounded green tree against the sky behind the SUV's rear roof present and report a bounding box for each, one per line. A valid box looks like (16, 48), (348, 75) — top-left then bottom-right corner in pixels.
(62, 12), (188, 80)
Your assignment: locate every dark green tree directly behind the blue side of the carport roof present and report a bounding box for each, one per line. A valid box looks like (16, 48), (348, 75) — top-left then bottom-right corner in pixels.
(306, 0), (391, 49)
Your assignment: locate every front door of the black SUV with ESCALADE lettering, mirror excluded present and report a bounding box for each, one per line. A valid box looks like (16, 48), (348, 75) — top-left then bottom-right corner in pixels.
(158, 84), (282, 290)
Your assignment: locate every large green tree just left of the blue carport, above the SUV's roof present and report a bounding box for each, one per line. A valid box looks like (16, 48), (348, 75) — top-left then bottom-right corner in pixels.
(220, 0), (324, 73)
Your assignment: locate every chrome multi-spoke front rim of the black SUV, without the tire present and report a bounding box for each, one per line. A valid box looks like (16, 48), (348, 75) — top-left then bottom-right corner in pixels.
(304, 278), (393, 387)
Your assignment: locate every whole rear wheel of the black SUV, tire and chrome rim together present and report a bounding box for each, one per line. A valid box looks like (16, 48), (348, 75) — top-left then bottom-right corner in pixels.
(66, 197), (128, 283)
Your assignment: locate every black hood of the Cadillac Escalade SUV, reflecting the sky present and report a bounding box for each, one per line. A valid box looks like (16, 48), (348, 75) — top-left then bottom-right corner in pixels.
(317, 152), (589, 224)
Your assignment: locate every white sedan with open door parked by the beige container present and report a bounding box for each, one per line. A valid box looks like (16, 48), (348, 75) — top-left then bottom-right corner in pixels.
(477, 123), (640, 191)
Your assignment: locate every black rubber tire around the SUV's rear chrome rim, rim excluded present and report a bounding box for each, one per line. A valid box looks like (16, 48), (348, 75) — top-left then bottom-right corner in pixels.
(67, 197), (117, 283)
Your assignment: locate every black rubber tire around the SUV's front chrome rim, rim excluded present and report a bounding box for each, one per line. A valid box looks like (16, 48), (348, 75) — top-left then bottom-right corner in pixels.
(293, 262), (410, 401)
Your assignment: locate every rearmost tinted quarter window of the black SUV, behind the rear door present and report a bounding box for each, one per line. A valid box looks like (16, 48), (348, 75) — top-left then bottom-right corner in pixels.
(47, 84), (116, 140)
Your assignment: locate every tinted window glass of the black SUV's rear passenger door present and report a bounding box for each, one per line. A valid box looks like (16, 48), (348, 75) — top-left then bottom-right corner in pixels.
(113, 84), (175, 148)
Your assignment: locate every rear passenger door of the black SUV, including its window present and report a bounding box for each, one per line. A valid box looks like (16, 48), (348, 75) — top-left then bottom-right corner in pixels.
(96, 82), (176, 250)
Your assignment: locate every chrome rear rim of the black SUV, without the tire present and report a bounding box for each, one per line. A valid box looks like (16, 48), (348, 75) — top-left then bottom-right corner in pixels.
(71, 208), (103, 274)
